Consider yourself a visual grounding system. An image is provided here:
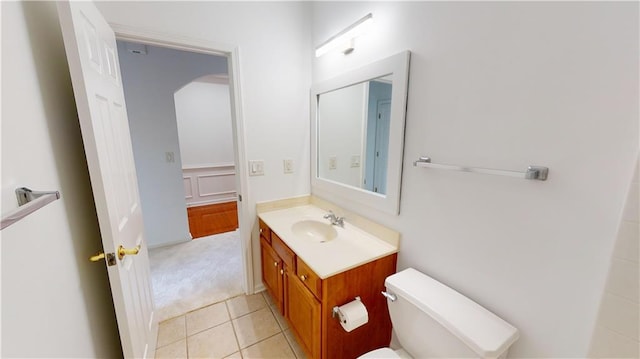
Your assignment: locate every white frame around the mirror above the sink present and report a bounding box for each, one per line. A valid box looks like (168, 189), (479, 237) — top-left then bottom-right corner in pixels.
(311, 51), (411, 215)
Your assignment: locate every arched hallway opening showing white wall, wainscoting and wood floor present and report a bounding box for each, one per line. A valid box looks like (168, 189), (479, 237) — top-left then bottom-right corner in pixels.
(173, 74), (238, 239)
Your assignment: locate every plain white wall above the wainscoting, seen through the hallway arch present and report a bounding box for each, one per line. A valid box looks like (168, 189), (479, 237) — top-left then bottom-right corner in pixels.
(174, 81), (234, 168)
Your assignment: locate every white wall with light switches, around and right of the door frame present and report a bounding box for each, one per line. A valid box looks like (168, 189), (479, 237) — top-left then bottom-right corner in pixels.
(96, 2), (312, 283)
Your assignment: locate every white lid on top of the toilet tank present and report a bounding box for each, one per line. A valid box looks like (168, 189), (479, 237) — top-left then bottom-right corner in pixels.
(385, 268), (518, 358)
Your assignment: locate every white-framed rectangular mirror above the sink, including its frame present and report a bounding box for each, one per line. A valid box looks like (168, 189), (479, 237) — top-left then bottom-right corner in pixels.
(311, 51), (410, 214)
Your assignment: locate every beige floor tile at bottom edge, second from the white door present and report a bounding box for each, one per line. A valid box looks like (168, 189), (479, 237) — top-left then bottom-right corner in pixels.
(187, 322), (238, 358)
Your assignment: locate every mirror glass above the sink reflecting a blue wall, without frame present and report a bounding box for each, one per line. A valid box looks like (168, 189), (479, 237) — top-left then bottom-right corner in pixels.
(317, 76), (392, 194)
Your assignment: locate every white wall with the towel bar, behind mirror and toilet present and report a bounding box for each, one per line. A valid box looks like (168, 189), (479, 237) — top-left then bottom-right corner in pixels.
(312, 2), (639, 357)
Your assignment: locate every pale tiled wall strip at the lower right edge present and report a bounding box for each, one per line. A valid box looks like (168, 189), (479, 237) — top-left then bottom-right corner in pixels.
(589, 159), (640, 358)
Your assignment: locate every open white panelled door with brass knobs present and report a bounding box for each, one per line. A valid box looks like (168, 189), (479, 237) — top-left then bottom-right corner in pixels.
(58, 1), (158, 358)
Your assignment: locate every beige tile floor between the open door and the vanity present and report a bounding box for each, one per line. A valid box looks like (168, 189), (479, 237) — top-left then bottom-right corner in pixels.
(156, 292), (306, 359)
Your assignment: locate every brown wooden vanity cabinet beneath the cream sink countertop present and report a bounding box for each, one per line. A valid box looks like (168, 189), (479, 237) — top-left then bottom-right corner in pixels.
(259, 220), (397, 359)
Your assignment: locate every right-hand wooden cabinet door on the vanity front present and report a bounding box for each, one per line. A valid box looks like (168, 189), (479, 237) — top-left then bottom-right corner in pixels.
(285, 273), (321, 358)
